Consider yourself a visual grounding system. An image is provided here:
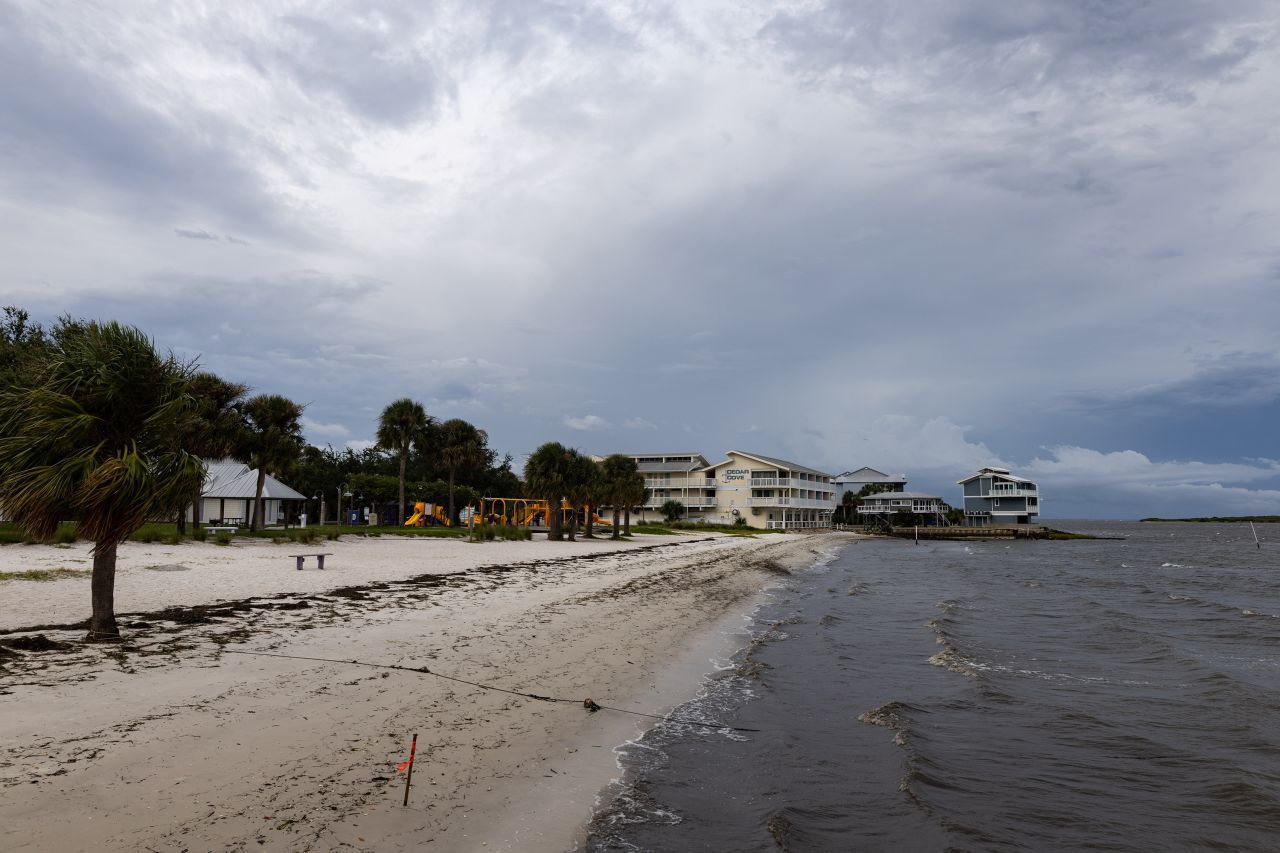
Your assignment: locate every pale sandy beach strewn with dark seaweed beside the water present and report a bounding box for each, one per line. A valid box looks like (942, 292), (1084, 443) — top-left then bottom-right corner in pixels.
(0, 534), (847, 850)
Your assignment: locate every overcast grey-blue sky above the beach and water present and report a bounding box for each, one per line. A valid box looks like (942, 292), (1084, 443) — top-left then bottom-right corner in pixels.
(0, 0), (1280, 517)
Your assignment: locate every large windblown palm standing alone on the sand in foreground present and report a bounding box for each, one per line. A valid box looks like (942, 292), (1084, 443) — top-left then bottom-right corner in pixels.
(0, 320), (205, 640)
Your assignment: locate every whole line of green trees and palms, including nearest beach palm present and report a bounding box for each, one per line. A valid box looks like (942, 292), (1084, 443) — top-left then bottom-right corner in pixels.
(0, 306), (645, 640)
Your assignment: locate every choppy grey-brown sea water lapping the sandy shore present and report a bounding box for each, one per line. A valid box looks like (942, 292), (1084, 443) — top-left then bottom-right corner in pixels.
(588, 523), (1280, 853)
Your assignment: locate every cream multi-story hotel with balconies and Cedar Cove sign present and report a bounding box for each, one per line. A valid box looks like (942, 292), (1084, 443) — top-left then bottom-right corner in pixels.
(631, 451), (836, 530)
